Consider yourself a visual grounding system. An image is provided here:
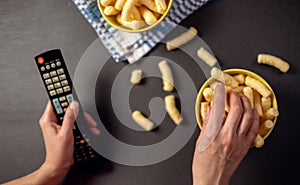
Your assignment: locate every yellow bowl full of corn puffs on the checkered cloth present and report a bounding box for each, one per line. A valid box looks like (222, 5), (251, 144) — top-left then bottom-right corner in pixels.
(98, 0), (173, 32)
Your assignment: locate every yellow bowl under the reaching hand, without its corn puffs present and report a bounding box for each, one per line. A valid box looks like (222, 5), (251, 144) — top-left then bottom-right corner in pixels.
(195, 69), (278, 139)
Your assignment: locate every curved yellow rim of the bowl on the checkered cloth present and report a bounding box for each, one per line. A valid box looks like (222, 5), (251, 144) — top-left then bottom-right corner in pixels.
(97, 0), (173, 33)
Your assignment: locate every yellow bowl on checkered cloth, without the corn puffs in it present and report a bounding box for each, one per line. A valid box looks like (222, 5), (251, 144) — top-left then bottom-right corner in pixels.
(97, 0), (173, 33)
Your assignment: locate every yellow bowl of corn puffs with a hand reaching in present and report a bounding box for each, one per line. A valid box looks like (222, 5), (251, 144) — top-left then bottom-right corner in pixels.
(195, 67), (279, 148)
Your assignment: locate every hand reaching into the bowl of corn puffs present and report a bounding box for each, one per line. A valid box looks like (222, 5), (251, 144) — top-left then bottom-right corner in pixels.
(192, 88), (259, 185)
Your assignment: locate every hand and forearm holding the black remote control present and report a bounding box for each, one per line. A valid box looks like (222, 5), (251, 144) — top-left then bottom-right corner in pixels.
(3, 101), (100, 185)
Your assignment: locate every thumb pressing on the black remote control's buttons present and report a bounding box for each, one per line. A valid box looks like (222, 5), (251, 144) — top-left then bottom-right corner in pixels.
(61, 101), (79, 134)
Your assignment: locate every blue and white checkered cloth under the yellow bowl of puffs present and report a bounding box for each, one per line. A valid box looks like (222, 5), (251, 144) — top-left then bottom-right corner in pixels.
(72, 0), (209, 63)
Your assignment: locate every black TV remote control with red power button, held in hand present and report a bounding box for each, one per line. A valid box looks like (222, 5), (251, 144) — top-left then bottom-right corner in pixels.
(35, 49), (96, 162)
